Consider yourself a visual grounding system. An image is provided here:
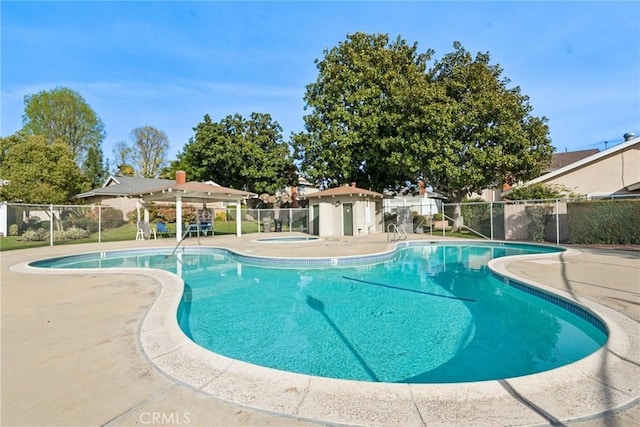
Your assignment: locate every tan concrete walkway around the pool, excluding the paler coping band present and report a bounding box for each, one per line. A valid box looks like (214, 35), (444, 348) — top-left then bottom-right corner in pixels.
(0, 235), (640, 427)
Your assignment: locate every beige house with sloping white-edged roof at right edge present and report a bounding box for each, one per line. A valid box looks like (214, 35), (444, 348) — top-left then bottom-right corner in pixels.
(522, 134), (640, 199)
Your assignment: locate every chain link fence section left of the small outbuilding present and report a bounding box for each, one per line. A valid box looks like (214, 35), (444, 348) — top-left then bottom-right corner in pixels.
(0, 203), (309, 250)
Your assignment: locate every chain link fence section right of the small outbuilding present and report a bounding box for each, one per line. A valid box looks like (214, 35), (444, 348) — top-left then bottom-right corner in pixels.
(385, 198), (640, 245)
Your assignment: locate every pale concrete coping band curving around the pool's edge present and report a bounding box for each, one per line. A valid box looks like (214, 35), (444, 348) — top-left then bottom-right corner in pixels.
(12, 242), (640, 426)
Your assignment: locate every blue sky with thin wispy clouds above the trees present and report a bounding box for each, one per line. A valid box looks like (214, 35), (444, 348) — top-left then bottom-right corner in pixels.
(0, 0), (640, 167)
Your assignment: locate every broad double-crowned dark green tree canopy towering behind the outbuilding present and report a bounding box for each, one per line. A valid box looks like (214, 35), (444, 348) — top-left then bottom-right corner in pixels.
(293, 33), (553, 227)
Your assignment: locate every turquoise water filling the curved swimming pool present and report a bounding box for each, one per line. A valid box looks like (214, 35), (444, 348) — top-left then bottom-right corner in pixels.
(36, 243), (607, 383)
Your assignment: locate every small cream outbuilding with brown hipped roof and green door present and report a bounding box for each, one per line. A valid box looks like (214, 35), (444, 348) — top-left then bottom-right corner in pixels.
(304, 182), (384, 237)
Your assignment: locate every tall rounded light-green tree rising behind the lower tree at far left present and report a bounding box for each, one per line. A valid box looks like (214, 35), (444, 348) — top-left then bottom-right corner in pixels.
(22, 87), (106, 169)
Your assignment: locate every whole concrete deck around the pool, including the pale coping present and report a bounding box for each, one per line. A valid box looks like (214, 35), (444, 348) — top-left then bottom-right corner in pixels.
(0, 234), (640, 426)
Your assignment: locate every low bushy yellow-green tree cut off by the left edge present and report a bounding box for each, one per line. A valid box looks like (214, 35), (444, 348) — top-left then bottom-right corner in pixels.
(0, 135), (89, 204)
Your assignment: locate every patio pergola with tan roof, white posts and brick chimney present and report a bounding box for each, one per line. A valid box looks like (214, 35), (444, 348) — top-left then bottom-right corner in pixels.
(134, 171), (257, 242)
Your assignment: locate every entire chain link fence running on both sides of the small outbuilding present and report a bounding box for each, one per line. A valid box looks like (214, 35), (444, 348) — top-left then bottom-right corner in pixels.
(0, 198), (640, 250)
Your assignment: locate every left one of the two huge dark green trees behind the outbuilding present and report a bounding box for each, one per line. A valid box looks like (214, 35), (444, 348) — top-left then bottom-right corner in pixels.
(293, 32), (439, 191)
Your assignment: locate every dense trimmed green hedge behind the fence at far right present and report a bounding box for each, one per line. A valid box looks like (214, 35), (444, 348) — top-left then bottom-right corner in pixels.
(567, 200), (640, 245)
